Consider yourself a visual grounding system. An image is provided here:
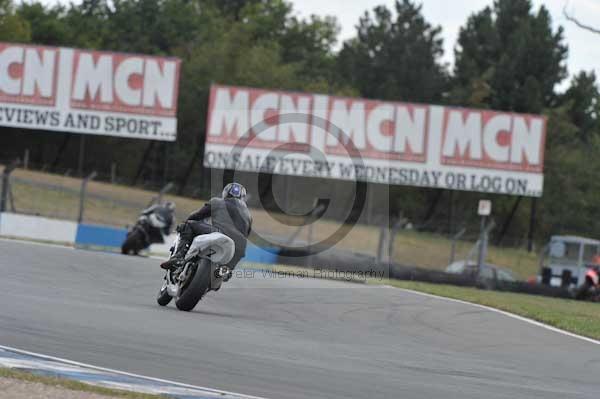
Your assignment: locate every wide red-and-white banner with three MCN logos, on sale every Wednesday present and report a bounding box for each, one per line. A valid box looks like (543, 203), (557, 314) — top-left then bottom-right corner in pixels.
(204, 86), (546, 197)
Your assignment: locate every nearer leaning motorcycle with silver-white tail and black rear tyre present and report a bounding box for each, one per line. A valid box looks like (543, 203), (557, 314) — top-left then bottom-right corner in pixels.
(156, 233), (235, 312)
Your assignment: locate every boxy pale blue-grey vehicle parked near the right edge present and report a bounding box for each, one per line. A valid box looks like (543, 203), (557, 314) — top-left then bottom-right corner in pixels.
(539, 236), (600, 290)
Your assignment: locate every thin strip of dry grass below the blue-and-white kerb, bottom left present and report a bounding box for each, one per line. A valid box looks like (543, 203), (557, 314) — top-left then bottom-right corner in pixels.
(0, 368), (165, 399)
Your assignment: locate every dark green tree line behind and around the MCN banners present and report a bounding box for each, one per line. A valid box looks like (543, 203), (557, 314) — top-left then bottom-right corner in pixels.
(0, 0), (600, 244)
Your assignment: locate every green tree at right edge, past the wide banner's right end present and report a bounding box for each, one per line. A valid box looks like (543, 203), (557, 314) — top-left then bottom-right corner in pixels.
(541, 72), (600, 237)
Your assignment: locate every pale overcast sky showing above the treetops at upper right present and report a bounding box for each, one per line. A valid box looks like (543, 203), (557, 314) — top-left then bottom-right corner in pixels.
(291, 0), (600, 89)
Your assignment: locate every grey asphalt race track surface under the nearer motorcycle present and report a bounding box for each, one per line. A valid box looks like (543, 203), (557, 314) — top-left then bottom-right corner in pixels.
(0, 241), (600, 399)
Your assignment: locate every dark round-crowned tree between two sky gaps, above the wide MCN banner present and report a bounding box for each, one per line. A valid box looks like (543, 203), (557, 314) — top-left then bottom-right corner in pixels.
(338, 0), (447, 102)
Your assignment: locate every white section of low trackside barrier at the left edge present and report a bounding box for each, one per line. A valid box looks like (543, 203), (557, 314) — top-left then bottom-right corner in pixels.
(0, 213), (77, 244)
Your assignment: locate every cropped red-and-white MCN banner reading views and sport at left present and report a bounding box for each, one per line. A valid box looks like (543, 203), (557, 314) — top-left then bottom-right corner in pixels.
(0, 43), (180, 141)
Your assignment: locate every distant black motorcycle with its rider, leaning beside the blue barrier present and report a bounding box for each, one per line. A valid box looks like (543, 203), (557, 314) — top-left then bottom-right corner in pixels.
(121, 202), (175, 255)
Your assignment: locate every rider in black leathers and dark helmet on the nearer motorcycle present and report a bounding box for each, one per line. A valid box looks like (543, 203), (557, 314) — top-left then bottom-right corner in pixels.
(160, 183), (252, 272)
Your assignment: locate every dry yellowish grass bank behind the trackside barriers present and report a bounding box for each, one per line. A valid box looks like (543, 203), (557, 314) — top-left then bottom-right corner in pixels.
(2, 163), (538, 279)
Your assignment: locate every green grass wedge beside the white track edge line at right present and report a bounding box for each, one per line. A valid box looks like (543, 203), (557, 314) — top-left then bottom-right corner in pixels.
(375, 280), (600, 340)
